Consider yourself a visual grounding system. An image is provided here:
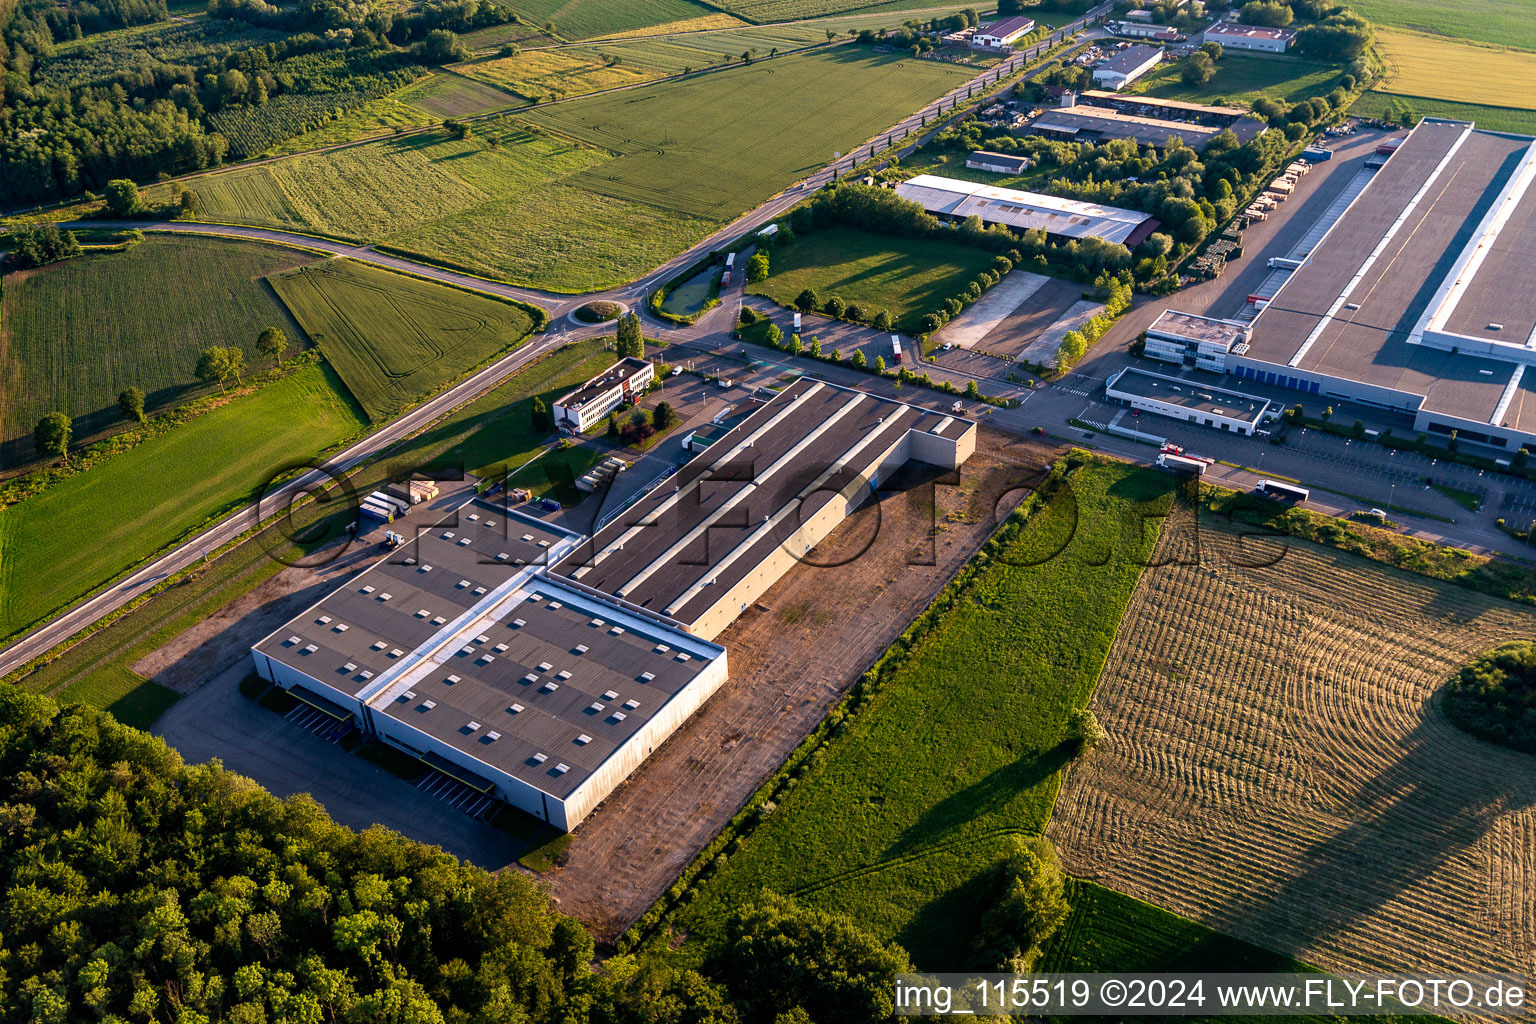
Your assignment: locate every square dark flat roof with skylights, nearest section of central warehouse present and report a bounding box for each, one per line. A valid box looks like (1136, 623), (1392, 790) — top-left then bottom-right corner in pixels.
(370, 577), (720, 800)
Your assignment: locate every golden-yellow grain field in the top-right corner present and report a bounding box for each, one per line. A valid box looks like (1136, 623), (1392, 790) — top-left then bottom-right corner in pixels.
(1372, 31), (1536, 111)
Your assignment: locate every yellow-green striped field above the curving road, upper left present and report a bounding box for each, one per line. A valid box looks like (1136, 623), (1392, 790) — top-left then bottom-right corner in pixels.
(151, 125), (716, 292)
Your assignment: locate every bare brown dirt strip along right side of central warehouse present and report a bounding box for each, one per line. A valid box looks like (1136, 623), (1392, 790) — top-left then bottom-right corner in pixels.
(547, 431), (1052, 938)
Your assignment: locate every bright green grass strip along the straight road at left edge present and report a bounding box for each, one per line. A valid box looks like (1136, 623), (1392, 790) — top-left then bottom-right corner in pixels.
(0, 365), (364, 637)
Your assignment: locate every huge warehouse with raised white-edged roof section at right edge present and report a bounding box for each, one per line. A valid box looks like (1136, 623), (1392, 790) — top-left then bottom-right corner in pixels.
(1204, 118), (1536, 451)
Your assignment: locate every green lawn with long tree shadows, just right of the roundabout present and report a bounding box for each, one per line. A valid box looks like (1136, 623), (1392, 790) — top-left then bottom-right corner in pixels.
(746, 227), (994, 335)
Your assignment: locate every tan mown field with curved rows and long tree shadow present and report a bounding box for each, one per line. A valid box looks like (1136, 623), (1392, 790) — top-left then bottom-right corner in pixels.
(1051, 512), (1536, 973)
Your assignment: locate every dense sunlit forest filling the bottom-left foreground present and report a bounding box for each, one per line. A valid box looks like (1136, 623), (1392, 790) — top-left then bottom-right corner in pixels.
(0, 686), (970, 1024)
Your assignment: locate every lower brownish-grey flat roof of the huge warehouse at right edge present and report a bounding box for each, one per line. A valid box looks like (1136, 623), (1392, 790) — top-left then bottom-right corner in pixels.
(1244, 120), (1536, 425)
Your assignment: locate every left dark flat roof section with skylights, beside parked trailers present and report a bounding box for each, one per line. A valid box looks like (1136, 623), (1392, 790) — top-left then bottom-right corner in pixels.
(257, 499), (574, 695)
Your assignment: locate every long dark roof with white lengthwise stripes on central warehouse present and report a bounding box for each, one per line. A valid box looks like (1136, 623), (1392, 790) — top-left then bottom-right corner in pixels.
(550, 378), (974, 623)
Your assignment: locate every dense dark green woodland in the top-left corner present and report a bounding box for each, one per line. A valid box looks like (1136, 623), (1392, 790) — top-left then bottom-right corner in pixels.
(0, 0), (516, 204)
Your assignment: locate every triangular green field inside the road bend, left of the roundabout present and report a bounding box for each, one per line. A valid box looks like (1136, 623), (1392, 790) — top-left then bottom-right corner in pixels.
(270, 259), (533, 422)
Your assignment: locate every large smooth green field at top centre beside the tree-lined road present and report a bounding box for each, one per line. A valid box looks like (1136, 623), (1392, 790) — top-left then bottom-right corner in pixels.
(527, 48), (971, 221)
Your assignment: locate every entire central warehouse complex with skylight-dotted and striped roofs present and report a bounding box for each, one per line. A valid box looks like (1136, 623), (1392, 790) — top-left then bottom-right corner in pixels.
(252, 378), (977, 831)
